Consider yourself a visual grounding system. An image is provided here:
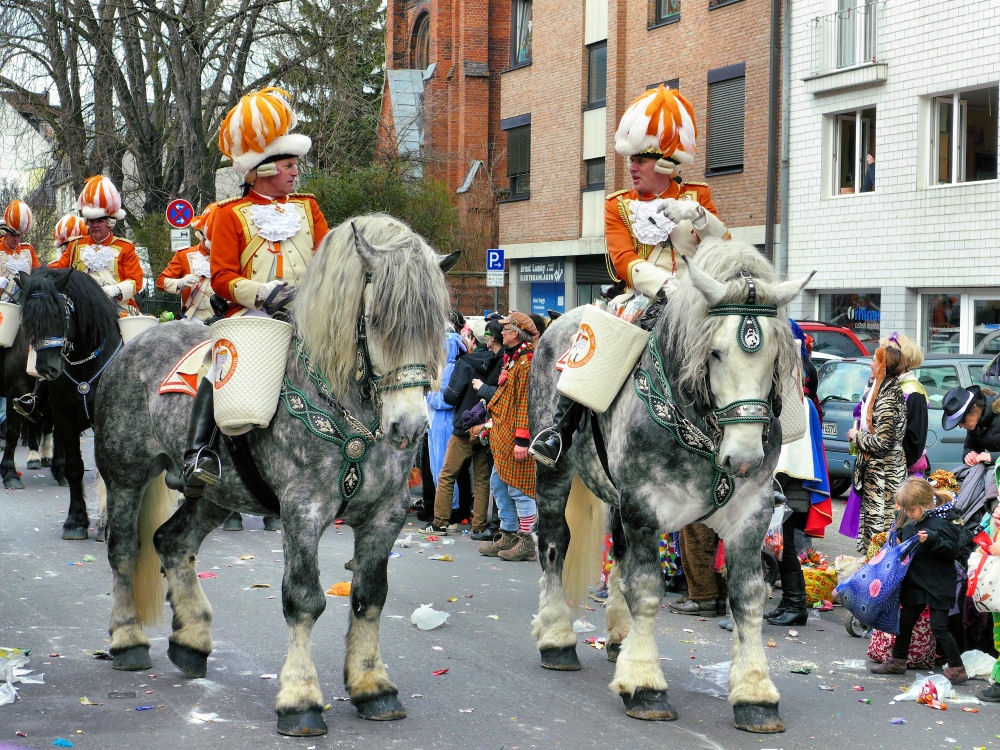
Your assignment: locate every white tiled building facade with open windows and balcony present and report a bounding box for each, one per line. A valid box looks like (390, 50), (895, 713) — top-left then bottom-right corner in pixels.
(786, 0), (1000, 353)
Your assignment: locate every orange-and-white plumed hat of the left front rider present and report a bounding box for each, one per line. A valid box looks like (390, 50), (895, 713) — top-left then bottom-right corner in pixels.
(219, 87), (312, 179)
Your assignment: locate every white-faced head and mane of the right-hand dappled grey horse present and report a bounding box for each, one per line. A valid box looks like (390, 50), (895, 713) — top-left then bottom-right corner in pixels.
(669, 239), (812, 477)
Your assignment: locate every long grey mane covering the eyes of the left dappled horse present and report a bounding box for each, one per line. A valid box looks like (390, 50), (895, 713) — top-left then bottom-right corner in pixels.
(292, 213), (448, 393)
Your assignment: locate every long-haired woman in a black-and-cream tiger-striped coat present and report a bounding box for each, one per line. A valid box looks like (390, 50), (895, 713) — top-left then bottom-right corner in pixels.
(847, 344), (906, 552)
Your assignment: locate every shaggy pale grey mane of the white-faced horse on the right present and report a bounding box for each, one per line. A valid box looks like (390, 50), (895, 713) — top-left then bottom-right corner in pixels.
(661, 237), (801, 404)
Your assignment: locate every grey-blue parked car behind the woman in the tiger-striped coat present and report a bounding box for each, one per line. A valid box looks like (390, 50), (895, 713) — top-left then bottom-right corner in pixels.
(816, 354), (991, 496)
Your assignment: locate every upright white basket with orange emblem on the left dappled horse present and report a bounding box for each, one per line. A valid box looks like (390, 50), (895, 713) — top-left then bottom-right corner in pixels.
(210, 315), (294, 435)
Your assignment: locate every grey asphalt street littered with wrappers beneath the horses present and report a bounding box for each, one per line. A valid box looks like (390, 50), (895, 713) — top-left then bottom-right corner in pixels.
(0, 438), (1000, 750)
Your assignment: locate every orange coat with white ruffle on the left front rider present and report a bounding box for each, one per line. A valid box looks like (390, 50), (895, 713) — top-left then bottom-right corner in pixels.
(210, 190), (330, 316)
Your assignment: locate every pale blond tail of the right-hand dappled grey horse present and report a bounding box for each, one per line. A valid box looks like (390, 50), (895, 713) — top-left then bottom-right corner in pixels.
(563, 477), (607, 607)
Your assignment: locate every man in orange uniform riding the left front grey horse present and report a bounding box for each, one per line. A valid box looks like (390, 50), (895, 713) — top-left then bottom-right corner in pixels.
(182, 88), (329, 506)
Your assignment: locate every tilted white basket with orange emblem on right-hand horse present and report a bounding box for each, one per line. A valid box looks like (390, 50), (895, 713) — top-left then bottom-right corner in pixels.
(556, 305), (649, 414)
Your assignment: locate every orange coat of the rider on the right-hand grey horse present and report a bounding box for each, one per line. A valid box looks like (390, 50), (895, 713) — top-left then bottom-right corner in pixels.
(604, 180), (728, 286)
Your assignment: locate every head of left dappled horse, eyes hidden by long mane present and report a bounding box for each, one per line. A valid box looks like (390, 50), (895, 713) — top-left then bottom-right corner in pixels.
(294, 214), (458, 450)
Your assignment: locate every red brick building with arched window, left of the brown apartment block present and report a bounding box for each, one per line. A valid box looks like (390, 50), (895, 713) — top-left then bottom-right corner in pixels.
(378, 0), (511, 314)
